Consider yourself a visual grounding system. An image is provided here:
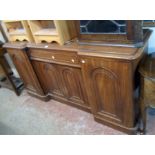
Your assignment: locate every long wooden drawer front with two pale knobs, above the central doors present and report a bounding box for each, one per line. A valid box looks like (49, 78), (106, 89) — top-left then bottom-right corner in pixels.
(30, 49), (79, 64)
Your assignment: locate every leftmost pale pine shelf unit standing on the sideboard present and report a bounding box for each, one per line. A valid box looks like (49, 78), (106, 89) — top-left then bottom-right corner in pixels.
(2, 20), (33, 42)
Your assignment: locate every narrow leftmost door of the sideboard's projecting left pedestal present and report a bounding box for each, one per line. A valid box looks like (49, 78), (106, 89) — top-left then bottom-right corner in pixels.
(7, 49), (44, 95)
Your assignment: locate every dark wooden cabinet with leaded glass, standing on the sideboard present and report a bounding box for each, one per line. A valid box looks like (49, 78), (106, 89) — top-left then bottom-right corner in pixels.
(76, 20), (145, 46)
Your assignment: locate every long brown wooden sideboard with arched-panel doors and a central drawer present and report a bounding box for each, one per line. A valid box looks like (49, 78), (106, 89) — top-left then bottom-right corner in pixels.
(4, 32), (150, 134)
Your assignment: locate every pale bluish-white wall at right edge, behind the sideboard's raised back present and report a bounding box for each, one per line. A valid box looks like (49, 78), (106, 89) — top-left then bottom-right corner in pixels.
(149, 27), (155, 53)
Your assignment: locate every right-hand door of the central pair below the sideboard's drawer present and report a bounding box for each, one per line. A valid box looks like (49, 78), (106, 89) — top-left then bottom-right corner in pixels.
(59, 66), (89, 107)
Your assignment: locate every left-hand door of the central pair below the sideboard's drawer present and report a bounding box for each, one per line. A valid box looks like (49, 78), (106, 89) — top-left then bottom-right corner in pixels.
(32, 60), (64, 97)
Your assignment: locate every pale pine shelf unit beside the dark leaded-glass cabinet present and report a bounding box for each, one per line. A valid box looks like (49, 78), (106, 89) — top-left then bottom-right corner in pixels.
(28, 20), (76, 45)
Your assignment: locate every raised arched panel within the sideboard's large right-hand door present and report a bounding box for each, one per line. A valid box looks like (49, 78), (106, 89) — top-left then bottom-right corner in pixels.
(91, 68), (121, 122)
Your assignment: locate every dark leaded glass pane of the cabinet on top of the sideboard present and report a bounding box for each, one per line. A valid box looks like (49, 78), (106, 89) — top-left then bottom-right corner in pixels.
(80, 20), (126, 34)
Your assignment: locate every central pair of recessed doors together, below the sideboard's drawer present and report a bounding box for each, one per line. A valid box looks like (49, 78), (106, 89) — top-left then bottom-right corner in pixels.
(32, 60), (90, 109)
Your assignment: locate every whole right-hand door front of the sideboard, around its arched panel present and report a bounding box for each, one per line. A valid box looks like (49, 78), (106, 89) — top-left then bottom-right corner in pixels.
(81, 56), (134, 127)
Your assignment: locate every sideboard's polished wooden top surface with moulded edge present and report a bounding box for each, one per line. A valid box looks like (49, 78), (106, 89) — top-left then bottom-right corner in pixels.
(3, 31), (152, 60)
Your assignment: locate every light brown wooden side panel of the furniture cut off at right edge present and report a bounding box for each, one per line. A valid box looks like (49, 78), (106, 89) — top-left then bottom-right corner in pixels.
(144, 78), (155, 107)
